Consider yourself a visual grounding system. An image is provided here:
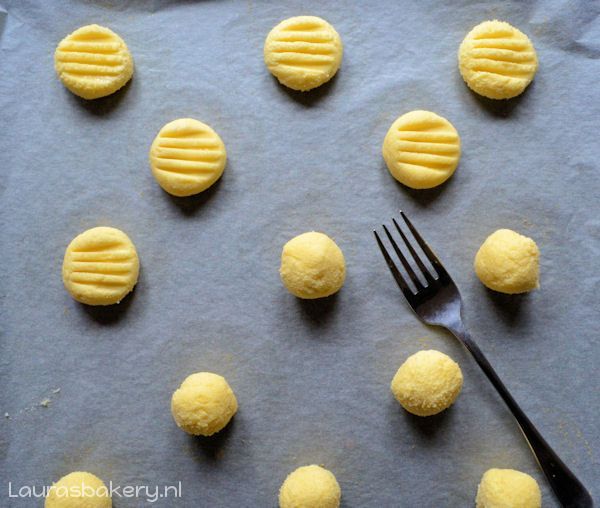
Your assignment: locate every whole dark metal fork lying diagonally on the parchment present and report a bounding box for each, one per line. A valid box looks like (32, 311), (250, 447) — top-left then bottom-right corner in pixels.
(373, 211), (594, 508)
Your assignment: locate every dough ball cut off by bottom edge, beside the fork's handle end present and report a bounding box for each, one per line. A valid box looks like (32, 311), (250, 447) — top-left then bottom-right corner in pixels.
(475, 469), (542, 508)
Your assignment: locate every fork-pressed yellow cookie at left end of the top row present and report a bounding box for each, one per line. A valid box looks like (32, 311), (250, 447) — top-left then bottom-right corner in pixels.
(54, 25), (133, 99)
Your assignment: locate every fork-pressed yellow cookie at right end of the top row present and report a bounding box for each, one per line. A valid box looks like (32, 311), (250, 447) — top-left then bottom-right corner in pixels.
(458, 20), (538, 99)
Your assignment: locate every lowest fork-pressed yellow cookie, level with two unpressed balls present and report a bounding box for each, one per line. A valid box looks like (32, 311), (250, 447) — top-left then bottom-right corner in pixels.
(62, 227), (140, 305)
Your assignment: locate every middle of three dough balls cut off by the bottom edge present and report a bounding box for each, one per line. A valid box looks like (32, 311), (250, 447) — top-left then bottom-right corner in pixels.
(279, 465), (342, 508)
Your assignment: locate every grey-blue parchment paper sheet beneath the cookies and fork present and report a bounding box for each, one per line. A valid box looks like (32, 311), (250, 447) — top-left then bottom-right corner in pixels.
(0, 0), (600, 508)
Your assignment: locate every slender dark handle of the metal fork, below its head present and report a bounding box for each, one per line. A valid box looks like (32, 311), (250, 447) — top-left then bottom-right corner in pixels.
(449, 322), (594, 508)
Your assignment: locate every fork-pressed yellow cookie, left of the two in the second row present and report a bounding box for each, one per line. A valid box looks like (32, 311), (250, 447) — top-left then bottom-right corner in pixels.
(150, 118), (227, 196)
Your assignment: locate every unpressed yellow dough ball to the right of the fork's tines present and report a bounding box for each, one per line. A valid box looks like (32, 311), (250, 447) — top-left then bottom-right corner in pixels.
(474, 229), (540, 294)
